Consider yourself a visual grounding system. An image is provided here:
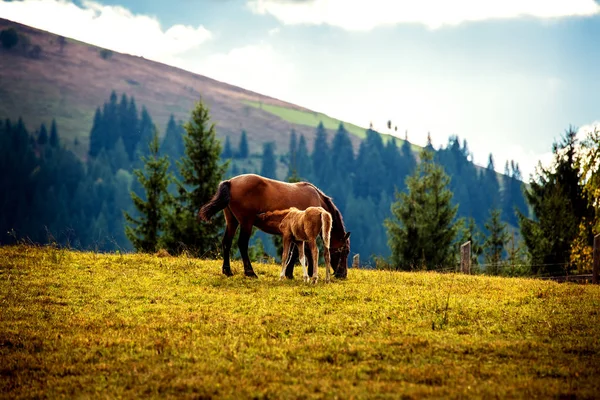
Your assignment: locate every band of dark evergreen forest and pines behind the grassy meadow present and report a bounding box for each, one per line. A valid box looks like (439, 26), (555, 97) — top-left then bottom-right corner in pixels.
(0, 92), (598, 273)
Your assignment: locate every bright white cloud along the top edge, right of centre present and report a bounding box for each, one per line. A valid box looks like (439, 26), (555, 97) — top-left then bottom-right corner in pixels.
(248, 0), (600, 31)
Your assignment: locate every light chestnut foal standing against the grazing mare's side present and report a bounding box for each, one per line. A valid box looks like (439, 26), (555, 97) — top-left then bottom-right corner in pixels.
(257, 207), (332, 283)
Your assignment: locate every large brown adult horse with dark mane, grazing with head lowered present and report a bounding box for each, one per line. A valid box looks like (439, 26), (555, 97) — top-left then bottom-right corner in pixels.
(198, 174), (350, 278)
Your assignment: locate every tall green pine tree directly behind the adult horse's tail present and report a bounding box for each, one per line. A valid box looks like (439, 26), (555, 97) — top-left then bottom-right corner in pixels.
(164, 101), (228, 257)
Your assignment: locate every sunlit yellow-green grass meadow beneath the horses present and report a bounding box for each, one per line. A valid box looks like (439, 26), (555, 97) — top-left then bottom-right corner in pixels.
(0, 246), (600, 399)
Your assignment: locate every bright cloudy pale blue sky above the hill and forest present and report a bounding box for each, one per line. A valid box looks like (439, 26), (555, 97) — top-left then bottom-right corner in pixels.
(0, 0), (600, 179)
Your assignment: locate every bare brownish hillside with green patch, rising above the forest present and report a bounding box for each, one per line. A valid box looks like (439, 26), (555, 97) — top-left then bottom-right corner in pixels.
(0, 18), (390, 156)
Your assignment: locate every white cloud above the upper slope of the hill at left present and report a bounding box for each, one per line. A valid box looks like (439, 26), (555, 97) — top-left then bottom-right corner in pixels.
(0, 0), (211, 62)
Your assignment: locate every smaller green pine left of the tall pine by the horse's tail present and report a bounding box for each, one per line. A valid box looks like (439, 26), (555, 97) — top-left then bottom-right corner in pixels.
(124, 131), (169, 253)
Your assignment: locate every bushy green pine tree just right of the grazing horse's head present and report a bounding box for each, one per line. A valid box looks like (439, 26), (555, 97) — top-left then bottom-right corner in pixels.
(384, 149), (457, 269)
